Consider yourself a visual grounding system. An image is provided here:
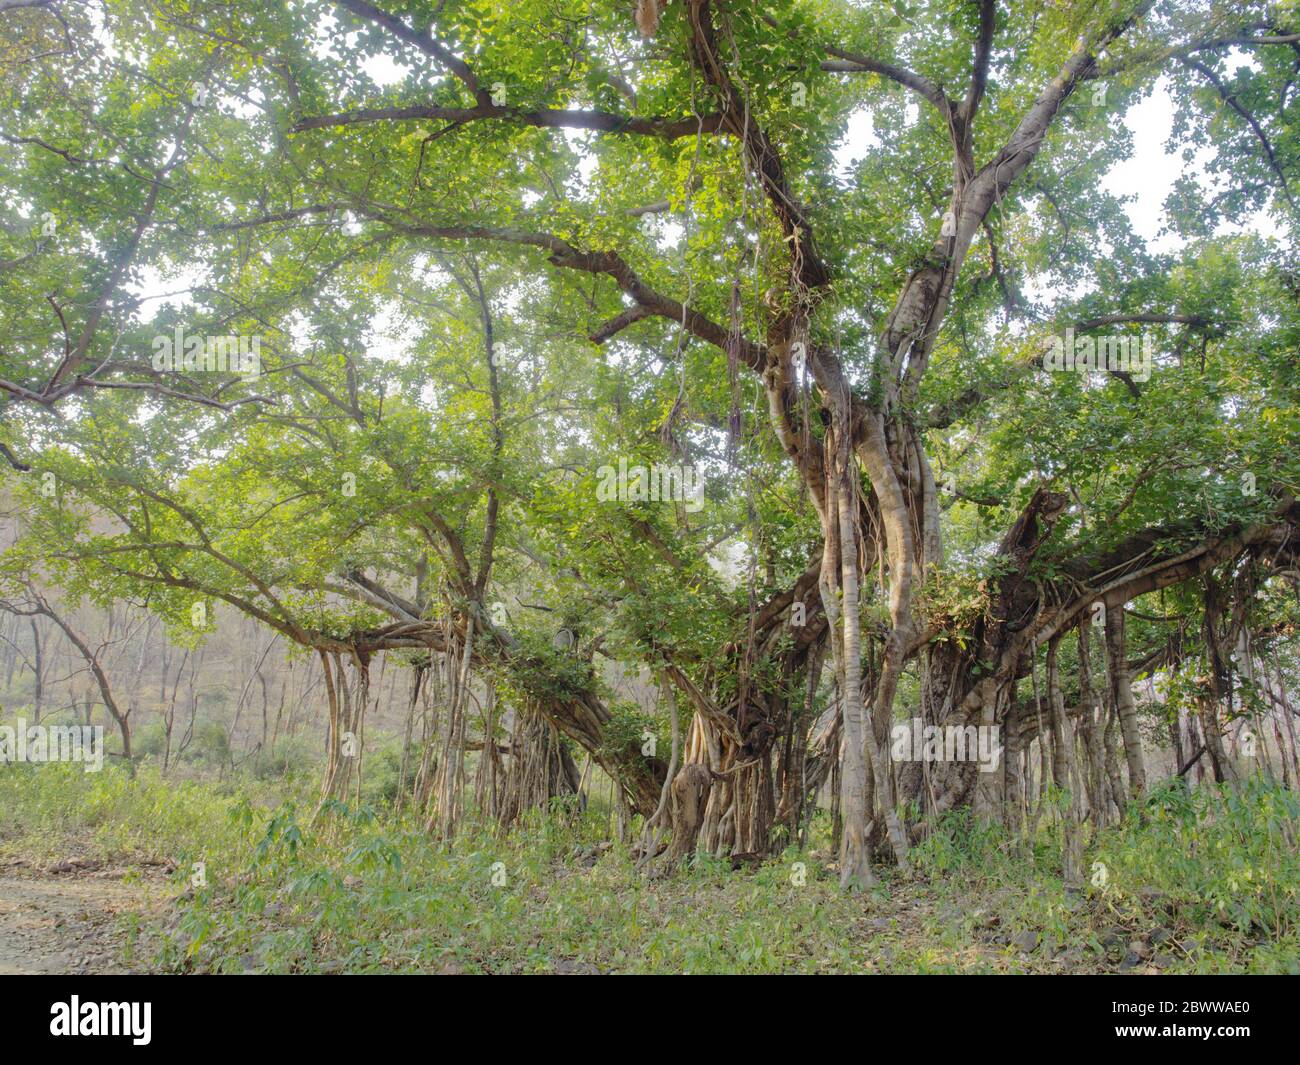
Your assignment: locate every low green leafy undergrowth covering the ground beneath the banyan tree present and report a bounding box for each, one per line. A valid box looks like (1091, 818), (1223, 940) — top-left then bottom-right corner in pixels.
(0, 766), (1300, 973)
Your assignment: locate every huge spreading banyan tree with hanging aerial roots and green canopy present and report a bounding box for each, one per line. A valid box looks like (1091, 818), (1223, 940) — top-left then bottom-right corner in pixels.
(0, 0), (1300, 887)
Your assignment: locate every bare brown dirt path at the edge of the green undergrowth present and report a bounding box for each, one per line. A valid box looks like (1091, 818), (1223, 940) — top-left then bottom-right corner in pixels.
(0, 860), (161, 975)
